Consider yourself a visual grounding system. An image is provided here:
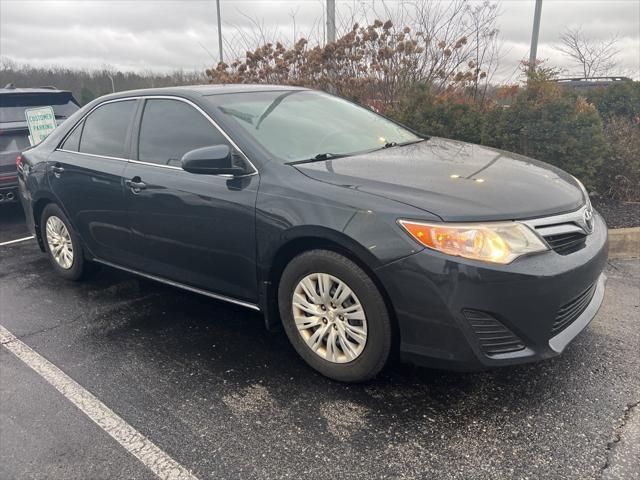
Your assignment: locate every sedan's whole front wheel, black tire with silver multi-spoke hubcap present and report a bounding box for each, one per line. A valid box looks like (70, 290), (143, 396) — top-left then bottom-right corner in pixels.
(278, 250), (392, 382)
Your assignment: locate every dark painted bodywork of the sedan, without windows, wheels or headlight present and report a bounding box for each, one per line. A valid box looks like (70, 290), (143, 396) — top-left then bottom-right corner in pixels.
(20, 85), (607, 369)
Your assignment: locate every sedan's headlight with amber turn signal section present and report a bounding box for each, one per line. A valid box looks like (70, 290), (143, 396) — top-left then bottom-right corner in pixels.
(399, 220), (548, 264)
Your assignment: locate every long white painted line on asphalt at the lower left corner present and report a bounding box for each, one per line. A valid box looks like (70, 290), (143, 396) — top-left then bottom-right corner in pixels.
(0, 325), (197, 480)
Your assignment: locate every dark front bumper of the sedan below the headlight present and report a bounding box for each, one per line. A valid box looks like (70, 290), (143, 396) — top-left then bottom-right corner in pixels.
(377, 214), (607, 370)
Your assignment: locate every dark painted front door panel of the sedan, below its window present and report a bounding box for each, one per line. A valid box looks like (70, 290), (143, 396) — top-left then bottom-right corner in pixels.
(125, 163), (260, 303)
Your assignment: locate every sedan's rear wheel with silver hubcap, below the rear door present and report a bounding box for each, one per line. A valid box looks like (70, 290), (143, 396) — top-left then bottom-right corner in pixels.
(40, 203), (85, 280)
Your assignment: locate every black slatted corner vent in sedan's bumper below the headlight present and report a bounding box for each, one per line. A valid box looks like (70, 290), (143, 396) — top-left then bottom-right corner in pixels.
(463, 310), (525, 357)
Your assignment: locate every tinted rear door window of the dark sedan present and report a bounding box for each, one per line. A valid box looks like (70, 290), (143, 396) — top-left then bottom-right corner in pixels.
(80, 100), (136, 158)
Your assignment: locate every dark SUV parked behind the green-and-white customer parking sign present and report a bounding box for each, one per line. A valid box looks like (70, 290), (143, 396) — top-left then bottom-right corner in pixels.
(0, 84), (80, 203)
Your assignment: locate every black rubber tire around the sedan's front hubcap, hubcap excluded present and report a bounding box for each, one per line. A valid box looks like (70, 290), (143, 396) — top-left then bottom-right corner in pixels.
(278, 250), (392, 382)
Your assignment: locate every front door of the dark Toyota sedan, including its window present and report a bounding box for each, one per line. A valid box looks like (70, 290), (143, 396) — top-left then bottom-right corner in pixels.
(125, 98), (259, 302)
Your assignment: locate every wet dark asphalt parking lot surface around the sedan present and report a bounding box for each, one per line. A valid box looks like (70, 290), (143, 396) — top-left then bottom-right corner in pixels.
(0, 201), (640, 479)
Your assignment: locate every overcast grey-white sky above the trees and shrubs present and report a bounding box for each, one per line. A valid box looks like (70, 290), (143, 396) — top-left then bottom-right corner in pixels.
(0, 0), (640, 80)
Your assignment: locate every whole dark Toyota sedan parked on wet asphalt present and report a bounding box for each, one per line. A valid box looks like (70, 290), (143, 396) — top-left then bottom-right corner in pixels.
(19, 85), (607, 381)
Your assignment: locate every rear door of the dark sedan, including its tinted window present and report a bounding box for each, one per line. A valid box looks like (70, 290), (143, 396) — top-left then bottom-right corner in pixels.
(47, 99), (138, 265)
